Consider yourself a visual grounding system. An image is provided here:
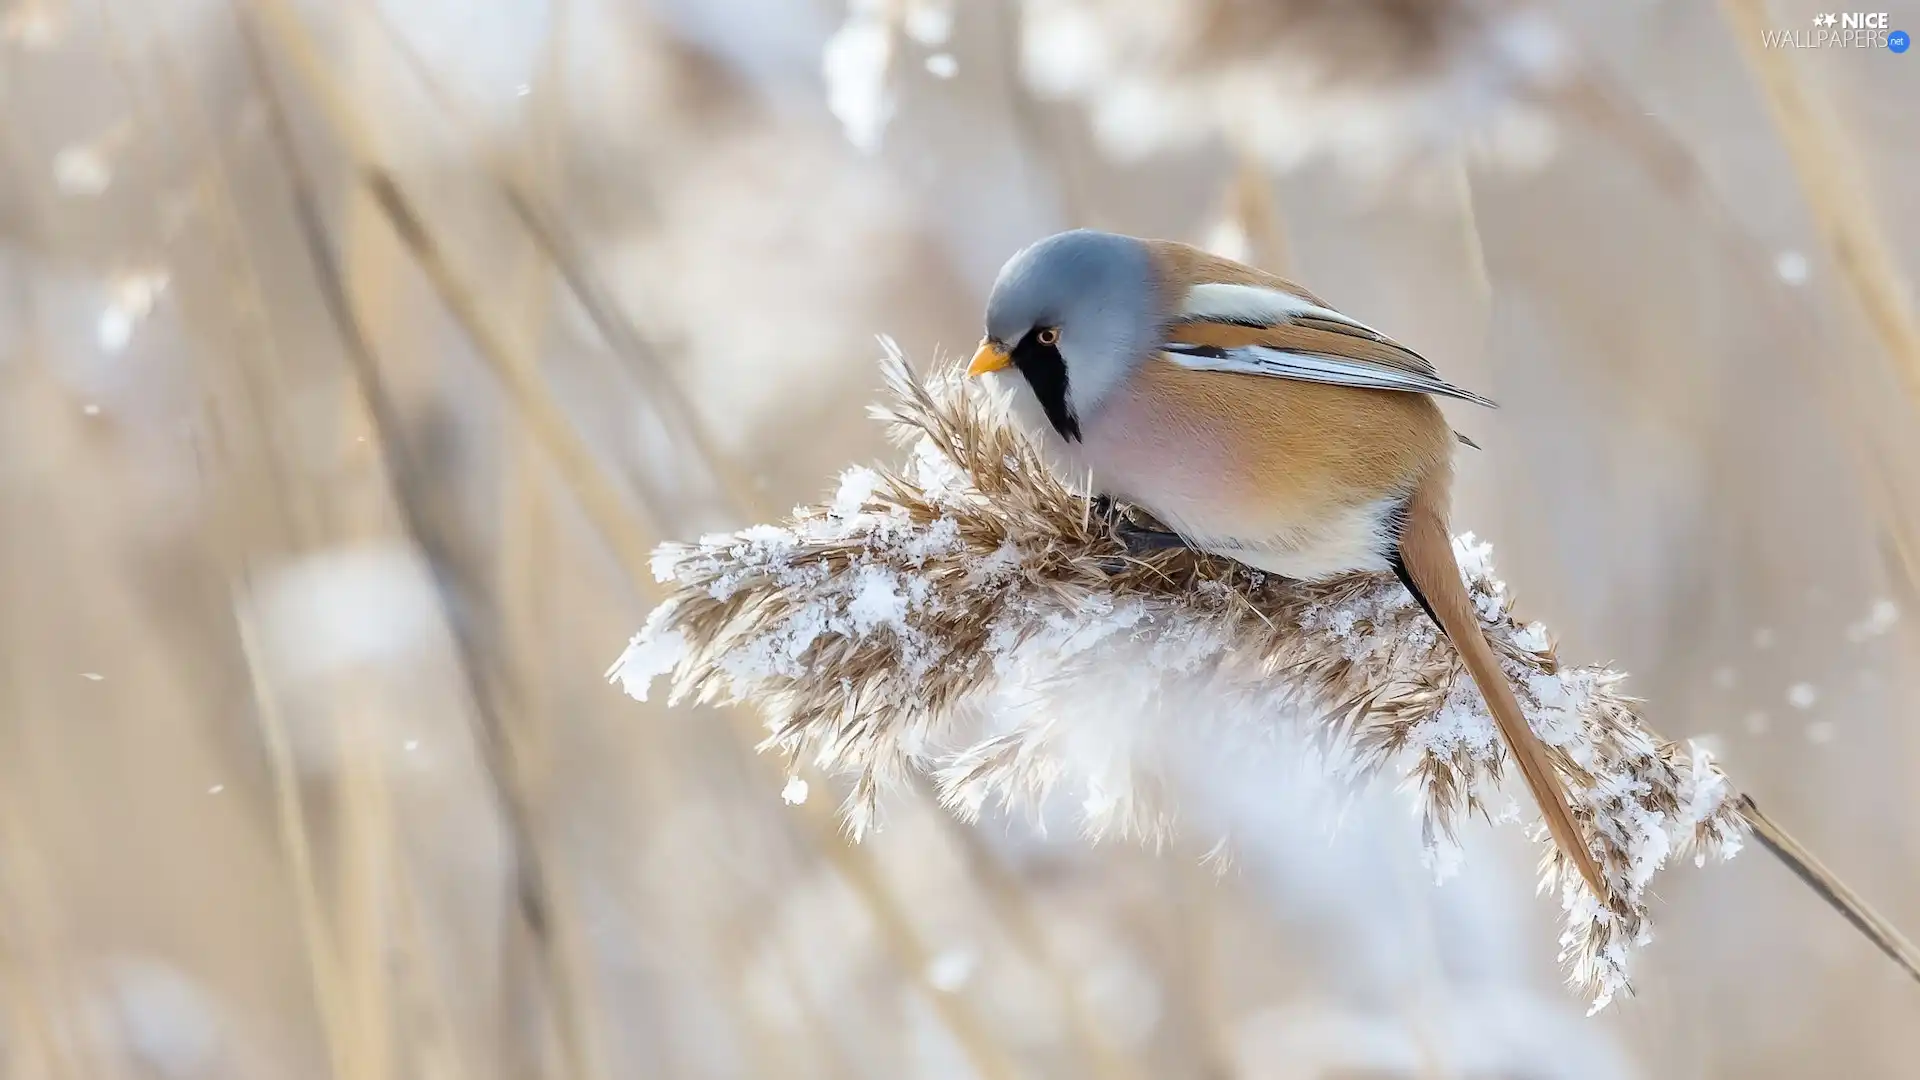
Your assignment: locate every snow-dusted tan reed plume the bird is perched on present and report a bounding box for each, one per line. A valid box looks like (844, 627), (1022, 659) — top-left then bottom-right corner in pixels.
(609, 346), (1743, 1009)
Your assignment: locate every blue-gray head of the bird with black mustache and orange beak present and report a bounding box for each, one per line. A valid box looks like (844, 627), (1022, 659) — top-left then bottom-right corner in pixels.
(970, 229), (1165, 438)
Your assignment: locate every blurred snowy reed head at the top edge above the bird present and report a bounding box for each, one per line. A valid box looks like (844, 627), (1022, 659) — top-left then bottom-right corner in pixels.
(1021, 0), (1569, 173)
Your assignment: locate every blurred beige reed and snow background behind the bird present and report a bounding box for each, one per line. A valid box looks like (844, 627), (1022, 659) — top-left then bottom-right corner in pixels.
(0, 0), (1920, 1080)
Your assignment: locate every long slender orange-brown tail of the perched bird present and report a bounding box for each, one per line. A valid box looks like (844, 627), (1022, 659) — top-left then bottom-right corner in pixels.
(1394, 490), (1613, 903)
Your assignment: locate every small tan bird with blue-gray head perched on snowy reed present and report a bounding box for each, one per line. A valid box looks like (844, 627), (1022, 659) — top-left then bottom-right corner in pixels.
(968, 229), (1611, 903)
